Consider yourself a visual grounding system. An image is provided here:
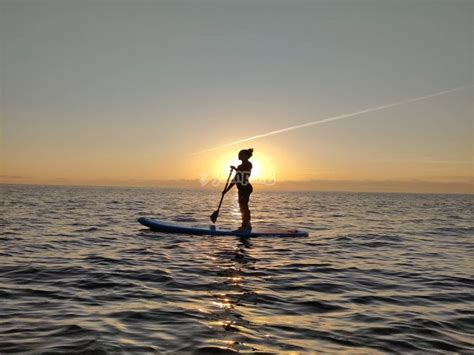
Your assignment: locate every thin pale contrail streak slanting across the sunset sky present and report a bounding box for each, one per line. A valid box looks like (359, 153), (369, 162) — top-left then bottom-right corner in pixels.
(192, 84), (474, 155)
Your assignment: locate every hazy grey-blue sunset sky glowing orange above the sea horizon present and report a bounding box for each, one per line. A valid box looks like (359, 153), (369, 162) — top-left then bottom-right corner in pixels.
(0, 0), (474, 193)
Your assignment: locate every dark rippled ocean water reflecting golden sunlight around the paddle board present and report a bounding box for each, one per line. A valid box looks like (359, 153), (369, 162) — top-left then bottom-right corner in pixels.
(0, 185), (474, 354)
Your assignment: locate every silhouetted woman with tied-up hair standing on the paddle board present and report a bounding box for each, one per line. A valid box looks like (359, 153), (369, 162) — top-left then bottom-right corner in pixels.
(223, 148), (253, 232)
